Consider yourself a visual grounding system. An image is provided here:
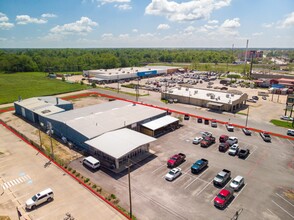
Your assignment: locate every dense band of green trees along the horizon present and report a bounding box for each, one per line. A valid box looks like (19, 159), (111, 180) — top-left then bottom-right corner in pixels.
(0, 48), (290, 73)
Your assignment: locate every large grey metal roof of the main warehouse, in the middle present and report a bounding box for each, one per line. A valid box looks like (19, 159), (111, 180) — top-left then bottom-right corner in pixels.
(48, 100), (166, 139)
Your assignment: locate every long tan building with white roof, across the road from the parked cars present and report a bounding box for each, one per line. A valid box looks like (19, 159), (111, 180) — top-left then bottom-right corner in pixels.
(161, 87), (248, 112)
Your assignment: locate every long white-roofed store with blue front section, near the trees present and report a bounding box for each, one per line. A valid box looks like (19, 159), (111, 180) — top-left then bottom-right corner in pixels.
(83, 66), (180, 83)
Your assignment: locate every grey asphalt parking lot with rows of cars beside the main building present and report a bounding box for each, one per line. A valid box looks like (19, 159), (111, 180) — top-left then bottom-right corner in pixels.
(71, 114), (294, 219)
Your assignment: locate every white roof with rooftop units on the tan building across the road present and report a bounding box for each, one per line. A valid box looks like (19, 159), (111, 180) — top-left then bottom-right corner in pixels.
(165, 87), (244, 104)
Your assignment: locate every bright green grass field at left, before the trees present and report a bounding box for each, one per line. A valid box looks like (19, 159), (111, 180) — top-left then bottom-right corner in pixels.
(0, 72), (87, 104)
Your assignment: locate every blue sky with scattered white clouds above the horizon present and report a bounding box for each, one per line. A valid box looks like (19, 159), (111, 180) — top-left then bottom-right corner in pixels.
(0, 0), (294, 48)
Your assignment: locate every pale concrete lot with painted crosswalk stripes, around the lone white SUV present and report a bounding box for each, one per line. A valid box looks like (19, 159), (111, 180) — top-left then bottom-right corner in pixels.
(0, 125), (126, 220)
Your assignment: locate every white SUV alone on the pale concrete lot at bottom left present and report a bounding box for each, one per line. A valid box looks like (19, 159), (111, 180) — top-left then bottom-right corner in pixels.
(26, 188), (54, 209)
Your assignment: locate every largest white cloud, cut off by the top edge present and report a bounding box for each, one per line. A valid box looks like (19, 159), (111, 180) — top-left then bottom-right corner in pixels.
(145, 0), (231, 21)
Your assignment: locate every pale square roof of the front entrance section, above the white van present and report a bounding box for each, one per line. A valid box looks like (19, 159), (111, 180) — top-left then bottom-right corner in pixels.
(85, 128), (156, 159)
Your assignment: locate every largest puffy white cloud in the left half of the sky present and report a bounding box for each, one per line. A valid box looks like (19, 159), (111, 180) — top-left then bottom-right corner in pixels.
(50, 17), (98, 35)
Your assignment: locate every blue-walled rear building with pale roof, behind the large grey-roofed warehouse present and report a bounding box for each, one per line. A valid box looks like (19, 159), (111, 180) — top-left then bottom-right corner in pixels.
(14, 96), (73, 124)
